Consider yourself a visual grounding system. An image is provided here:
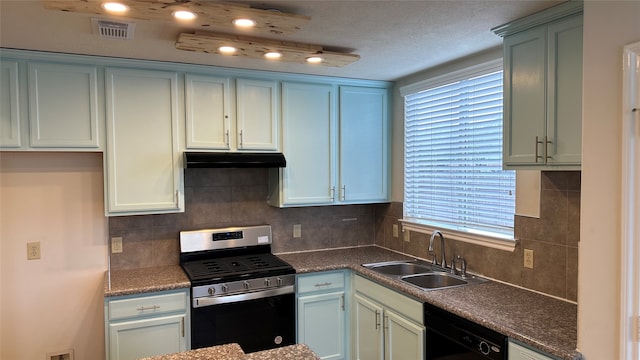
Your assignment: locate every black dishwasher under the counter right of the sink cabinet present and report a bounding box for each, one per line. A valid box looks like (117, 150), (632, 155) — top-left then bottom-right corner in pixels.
(424, 303), (507, 360)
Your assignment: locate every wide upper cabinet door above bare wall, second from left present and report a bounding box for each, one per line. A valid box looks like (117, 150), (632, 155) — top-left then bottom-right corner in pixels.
(28, 62), (102, 151)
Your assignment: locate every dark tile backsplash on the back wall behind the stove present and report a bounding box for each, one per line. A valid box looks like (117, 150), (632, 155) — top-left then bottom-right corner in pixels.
(109, 169), (375, 269)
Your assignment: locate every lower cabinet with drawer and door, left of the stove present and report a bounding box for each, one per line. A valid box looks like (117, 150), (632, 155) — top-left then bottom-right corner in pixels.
(104, 289), (190, 360)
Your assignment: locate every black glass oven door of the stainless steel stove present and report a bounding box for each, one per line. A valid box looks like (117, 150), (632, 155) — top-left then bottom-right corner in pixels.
(191, 289), (296, 353)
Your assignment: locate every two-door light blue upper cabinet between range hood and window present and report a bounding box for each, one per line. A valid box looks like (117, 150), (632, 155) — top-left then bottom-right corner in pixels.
(269, 82), (390, 207)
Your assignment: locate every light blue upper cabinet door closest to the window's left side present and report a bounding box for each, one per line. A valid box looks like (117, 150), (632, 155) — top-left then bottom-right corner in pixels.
(338, 86), (390, 203)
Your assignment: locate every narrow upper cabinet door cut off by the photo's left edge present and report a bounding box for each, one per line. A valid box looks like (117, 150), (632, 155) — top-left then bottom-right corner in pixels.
(0, 60), (23, 150)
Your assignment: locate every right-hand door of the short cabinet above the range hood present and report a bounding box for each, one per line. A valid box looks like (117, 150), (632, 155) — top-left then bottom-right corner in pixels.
(236, 79), (280, 151)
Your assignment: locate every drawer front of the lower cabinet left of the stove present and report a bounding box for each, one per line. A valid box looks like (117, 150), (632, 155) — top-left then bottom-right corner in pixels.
(108, 291), (187, 320)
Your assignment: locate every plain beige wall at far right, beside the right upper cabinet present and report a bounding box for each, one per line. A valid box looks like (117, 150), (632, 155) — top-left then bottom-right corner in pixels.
(578, 0), (640, 360)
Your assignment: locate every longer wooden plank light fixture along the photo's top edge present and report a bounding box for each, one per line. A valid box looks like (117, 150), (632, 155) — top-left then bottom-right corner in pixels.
(42, 0), (311, 35)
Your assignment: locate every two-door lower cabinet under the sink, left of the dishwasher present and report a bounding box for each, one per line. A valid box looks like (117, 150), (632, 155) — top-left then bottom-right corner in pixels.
(351, 275), (425, 360)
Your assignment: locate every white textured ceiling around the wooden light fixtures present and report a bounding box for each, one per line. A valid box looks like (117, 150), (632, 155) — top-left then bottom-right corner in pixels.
(0, 0), (559, 80)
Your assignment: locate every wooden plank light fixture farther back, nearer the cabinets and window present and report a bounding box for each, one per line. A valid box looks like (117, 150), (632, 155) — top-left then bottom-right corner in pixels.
(175, 32), (360, 67)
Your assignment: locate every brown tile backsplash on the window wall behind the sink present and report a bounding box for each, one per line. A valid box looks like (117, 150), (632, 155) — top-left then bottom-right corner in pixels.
(375, 171), (580, 301)
